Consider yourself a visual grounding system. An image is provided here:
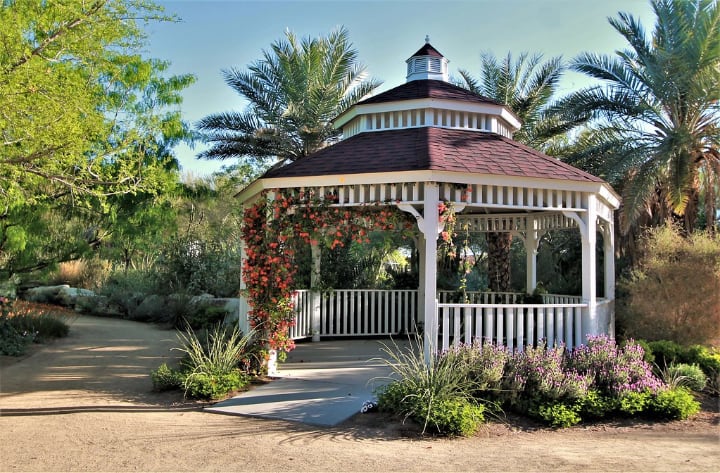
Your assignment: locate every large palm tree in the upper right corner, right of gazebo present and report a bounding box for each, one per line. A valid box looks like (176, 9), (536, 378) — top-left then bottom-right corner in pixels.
(559, 0), (720, 233)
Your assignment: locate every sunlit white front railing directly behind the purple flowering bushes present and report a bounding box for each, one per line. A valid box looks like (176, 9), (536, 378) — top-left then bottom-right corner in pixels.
(438, 303), (587, 351)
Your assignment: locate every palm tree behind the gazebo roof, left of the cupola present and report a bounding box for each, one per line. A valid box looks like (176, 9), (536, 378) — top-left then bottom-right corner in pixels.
(198, 28), (380, 164)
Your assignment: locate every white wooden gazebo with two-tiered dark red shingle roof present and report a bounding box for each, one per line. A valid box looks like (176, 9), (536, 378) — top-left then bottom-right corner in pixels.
(238, 42), (619, 366)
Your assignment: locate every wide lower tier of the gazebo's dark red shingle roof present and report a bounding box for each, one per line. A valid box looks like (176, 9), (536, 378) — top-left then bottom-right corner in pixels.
(262, 127), (603, 183)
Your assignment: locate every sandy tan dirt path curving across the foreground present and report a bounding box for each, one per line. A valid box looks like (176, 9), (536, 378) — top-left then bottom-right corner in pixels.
(0, 317), (720, 471)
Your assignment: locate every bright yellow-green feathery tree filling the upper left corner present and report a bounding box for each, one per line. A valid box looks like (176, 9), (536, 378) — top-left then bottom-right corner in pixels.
(0, 0), (194, 274)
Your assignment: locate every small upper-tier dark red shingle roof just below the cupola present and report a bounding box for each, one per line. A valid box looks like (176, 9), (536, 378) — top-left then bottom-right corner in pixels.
(357, 80), (502, 105)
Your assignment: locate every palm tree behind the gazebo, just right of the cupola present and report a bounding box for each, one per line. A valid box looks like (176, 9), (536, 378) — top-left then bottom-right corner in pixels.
(459, 52), (578, 292)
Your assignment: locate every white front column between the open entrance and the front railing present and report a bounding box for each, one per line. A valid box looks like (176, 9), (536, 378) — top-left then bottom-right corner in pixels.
(421, 182), (440, 363)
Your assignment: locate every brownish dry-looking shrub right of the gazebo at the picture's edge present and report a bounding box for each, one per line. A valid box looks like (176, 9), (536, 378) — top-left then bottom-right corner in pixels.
(618, 227), (720, 344)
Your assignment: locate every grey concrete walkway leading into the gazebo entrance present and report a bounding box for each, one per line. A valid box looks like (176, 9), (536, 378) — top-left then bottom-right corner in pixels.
(206, 340), (408, 426)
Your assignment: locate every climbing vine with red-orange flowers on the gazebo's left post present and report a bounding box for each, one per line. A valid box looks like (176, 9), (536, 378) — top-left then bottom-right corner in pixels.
(242, 190), (414, 359)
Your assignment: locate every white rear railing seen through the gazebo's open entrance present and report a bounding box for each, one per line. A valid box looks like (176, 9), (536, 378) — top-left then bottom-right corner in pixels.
(290, 289), (418, 339)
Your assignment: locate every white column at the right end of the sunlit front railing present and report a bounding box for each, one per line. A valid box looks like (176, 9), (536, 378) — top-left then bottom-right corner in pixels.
(581, 194), (602, 336)
